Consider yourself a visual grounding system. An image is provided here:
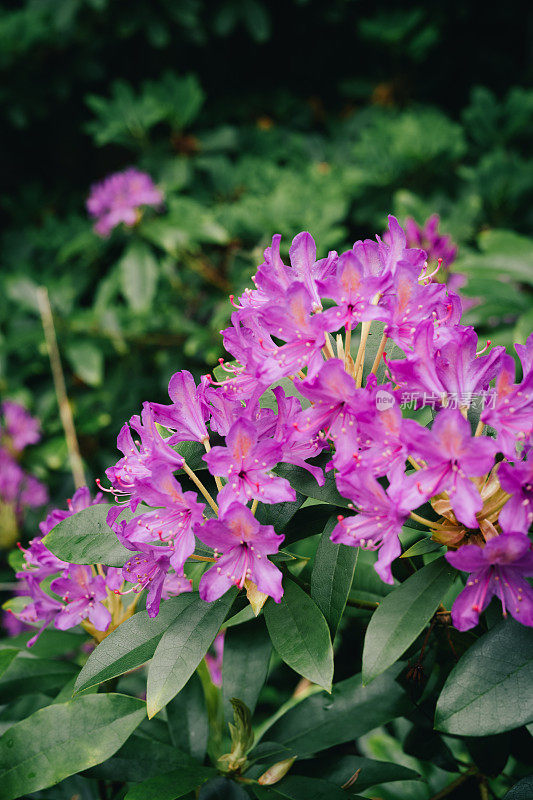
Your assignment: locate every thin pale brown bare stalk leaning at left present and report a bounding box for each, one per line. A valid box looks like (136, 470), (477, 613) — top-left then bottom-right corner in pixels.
(37, 286), (87, 489)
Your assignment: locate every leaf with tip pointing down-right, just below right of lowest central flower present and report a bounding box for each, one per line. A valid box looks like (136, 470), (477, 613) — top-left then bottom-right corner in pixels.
(264, 580), (333, 692)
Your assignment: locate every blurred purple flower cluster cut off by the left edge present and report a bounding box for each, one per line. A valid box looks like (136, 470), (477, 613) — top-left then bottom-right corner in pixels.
(0, 400), (48, 521)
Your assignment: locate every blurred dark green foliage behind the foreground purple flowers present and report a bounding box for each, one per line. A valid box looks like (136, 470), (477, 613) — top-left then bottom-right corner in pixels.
(0, 0), (533, 504)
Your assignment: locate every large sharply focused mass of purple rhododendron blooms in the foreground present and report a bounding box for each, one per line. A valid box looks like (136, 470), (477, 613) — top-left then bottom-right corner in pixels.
(12, 217), (533, 630)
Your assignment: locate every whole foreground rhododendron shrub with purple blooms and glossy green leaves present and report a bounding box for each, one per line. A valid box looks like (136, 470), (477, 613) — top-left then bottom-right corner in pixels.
(0, 217), (533, 800)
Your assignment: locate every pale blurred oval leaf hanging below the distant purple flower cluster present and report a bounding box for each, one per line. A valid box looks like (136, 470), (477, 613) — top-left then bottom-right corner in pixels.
(119, 241), (159, 313)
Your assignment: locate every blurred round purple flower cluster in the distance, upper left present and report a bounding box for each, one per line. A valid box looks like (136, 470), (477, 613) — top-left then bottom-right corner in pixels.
(87, 167), (163, 236)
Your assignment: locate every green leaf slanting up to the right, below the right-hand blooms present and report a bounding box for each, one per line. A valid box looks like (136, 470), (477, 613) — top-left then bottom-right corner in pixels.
(363, 558), (457, 684)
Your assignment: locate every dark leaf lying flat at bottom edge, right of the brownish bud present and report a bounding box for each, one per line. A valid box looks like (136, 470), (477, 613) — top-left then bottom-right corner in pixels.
(298, 754), (420, 792)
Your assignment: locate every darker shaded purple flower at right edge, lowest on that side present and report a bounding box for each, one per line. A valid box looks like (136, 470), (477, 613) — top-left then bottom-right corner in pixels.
(446, 533), (533, 631)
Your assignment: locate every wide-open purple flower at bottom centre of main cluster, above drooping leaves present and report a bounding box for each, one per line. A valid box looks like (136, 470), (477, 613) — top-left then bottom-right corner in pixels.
(196, 500), (283, 603)
